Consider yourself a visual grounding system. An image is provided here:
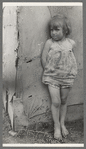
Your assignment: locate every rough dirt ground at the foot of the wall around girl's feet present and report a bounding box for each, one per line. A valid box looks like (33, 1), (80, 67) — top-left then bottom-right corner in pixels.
(2, 108), (84, 144)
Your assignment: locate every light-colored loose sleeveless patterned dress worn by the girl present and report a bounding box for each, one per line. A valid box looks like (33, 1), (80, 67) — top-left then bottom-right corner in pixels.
(42, 38), (77, 86)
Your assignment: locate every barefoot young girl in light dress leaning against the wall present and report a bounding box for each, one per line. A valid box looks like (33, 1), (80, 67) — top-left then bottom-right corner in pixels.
(42, 14), (77, 140)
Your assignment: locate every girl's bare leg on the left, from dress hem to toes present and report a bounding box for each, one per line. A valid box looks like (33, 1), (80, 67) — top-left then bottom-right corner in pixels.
(48, 85), (62, 140)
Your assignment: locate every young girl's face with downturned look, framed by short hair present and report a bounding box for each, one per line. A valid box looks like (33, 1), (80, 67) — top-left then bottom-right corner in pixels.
(50, 22), (65, 41)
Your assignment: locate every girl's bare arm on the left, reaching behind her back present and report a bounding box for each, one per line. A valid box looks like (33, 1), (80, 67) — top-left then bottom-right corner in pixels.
(42, 40), (51, 68)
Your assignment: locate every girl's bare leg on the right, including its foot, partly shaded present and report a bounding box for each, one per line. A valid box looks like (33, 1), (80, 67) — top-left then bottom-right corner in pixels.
(60, 88), (70, 137)
